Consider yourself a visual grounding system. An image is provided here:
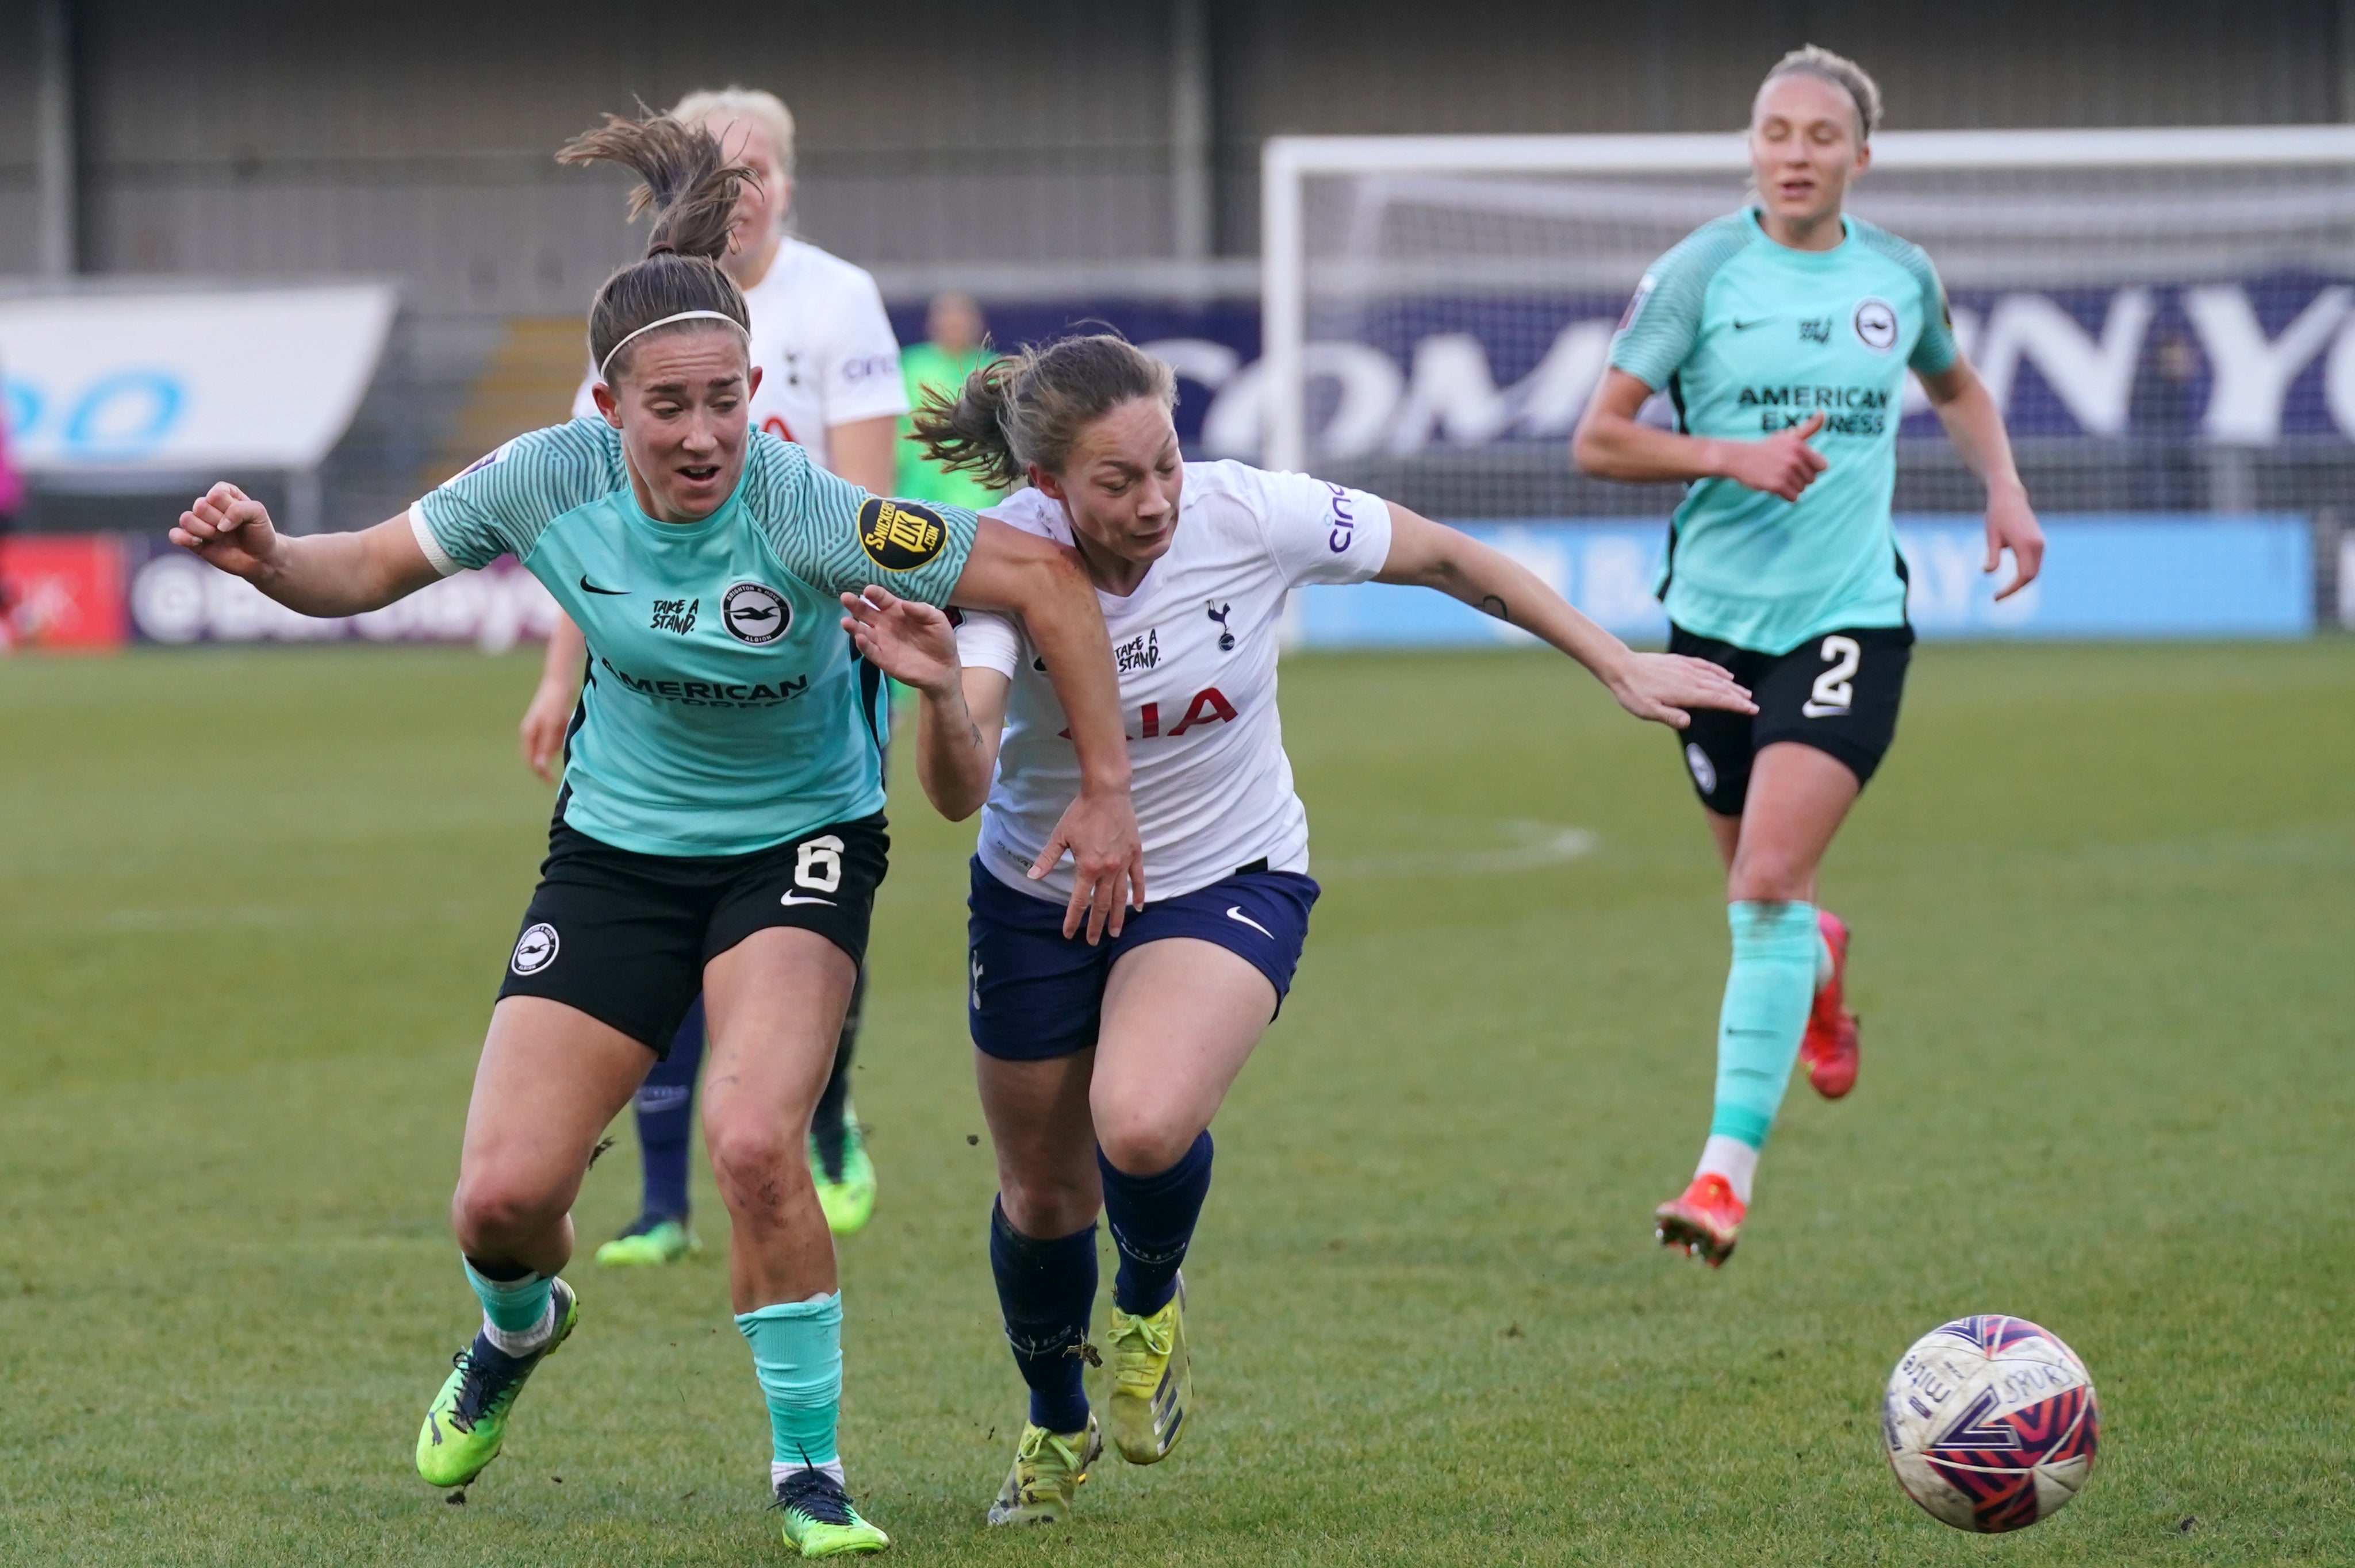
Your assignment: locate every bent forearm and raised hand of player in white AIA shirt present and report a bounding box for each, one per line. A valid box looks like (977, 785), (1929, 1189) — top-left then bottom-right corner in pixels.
(843, 589), (1012, 822)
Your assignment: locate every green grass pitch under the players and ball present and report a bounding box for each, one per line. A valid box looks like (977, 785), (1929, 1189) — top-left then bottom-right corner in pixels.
(0, 640), (2355, 1566)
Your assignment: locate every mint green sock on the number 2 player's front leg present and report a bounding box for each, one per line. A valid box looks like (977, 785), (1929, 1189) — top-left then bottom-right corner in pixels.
(1710, 902), (1823, 1149)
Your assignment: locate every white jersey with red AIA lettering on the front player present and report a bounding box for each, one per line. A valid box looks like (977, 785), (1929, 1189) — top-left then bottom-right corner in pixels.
(956, 462), (1390, 902)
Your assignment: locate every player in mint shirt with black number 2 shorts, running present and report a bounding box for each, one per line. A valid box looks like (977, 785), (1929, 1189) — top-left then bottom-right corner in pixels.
(1573, 45), (2044, 1267)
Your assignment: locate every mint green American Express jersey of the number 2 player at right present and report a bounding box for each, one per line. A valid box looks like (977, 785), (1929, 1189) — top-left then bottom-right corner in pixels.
(1611, 210), (1957, 655)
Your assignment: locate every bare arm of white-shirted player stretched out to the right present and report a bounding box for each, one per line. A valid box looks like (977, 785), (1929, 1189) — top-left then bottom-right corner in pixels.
(1375, 501), (1757, 730)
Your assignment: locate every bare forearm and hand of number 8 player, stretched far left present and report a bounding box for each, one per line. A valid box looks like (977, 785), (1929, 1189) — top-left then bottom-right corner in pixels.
(170, 481), (440, 617)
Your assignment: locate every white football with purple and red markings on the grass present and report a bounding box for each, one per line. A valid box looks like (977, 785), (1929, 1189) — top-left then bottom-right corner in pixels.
(1882, 1316), (2101, 1535)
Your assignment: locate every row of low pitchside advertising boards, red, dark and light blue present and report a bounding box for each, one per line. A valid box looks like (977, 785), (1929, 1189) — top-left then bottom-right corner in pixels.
(0, 513), (2317, 652)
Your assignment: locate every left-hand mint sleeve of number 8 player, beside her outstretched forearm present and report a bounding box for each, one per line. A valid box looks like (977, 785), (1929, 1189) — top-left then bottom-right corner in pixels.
(410, 419), (627, 577)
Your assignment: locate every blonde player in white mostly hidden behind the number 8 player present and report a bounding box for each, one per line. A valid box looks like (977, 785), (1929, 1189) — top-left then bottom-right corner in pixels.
(523, 87), (909, 1267)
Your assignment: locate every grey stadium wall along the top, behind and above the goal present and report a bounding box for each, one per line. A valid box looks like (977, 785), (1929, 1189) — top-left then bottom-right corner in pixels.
(0, 0), (2348, 301)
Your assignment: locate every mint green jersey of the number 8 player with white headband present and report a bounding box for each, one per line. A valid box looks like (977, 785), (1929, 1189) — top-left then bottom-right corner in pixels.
(410, 419), (977, 855)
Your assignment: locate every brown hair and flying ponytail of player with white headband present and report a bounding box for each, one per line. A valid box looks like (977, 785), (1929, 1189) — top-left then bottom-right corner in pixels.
(556, 116), (754, 382)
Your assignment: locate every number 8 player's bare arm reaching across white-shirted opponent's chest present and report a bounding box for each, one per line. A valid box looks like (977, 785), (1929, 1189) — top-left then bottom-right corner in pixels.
(949, 518), (1145, 941)
